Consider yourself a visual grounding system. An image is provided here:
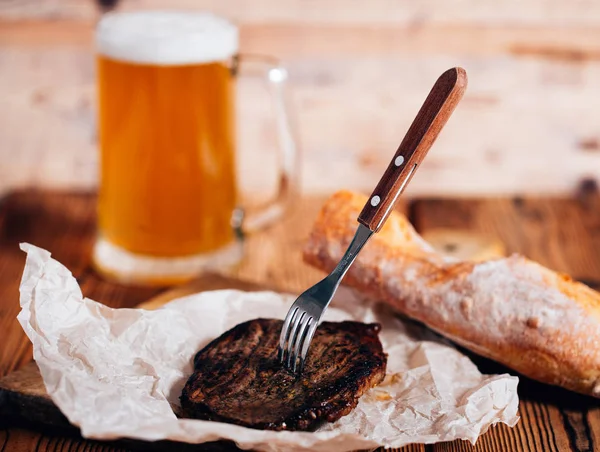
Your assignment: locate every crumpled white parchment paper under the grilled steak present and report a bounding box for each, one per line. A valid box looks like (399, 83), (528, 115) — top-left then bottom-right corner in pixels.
(18, 244), (519, 451)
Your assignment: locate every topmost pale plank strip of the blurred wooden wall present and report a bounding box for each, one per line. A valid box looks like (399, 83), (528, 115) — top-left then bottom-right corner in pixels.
(0, 0), (600, 26)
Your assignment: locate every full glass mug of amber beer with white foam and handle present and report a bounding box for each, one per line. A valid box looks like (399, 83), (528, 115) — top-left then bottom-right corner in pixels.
(93, 11), (297, 284)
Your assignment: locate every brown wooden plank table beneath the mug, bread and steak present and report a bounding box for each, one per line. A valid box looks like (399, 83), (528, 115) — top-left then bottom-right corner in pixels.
(0, 190), (600, 452)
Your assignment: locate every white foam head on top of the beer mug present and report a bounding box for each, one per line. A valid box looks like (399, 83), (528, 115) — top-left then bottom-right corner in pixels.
(96, 11), (238, 65)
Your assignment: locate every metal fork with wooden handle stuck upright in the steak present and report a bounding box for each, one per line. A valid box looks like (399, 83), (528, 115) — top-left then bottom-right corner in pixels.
(278, 68), (467, 373)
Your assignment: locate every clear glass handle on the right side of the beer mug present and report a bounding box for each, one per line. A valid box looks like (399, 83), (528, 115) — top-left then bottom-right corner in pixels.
(231, 54), (299, 235)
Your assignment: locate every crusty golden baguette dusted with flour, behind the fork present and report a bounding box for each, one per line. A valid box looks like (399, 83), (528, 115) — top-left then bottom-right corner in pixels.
(304, 191), (600, 397)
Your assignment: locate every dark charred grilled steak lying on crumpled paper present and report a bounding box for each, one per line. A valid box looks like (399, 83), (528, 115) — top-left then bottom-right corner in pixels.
(181, 319), (387, 430)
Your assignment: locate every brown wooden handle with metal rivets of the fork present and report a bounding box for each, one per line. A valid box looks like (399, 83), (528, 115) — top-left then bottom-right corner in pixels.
(358, 68), (467, 232)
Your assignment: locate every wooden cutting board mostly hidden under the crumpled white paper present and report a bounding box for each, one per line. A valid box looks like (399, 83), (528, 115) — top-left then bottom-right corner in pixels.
(0, 274), (277, 429)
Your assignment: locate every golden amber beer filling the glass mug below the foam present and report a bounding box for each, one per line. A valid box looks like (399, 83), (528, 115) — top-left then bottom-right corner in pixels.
(98, 55), (236, 256)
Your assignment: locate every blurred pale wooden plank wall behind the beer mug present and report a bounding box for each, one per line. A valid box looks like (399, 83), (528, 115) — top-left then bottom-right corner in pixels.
(0, 0), (600, 196)
